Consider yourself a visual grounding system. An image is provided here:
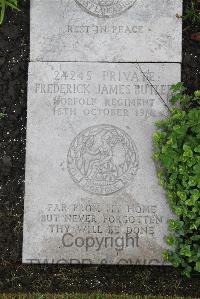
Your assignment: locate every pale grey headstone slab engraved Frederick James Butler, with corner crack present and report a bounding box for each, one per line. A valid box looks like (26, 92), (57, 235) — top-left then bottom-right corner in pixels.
(23, 62), (180, 264)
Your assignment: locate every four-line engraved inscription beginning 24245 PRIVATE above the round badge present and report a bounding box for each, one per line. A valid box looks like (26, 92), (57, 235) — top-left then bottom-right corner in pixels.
(34, 64), (171, 120)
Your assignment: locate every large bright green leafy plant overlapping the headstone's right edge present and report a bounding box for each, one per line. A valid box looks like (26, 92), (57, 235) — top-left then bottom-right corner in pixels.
(153, 83), (200, 277)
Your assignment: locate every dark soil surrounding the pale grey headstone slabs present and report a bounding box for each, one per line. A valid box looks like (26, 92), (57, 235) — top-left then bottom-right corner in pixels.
(0, 0), (200, 298)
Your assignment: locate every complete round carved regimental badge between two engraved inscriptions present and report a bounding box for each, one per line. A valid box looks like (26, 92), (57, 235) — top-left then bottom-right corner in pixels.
(67, 125), (138, 195)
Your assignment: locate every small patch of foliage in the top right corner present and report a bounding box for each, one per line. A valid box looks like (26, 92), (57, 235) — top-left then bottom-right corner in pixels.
(183, 0), (200, 25)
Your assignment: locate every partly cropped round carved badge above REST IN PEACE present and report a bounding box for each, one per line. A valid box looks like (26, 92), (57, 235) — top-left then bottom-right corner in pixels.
(75, 0), (136, 18)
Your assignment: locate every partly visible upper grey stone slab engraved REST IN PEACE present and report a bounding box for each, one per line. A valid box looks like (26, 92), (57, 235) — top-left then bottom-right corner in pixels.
(31, 0), (182, 62)
